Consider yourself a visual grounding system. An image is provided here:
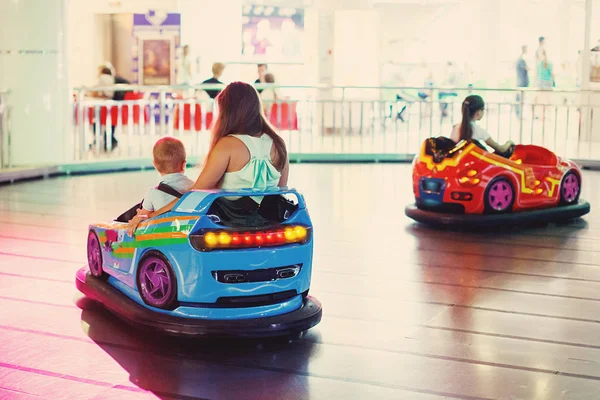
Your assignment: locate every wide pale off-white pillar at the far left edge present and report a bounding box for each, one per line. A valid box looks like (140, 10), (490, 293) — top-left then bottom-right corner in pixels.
(0, 0), (73, 166)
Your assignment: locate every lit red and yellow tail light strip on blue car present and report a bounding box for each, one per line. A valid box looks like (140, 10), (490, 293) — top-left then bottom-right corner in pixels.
(190, 225), (312, 251)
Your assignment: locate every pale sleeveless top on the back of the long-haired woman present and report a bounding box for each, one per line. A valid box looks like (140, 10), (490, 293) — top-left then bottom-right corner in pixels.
(221, 134), (281, 190)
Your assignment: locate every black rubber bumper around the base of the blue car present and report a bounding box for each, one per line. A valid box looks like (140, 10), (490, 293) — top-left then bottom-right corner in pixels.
(75, 267), (323, 338)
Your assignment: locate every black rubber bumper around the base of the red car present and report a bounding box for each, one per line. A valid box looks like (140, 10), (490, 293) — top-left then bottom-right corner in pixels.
(404, 200), (590, 227)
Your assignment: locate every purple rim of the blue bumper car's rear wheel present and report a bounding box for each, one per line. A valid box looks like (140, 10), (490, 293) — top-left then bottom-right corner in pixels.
(139, 257), (174, 307)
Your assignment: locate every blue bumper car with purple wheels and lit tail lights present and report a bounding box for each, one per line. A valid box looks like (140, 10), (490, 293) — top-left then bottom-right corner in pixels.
(76, 188), (322, 337)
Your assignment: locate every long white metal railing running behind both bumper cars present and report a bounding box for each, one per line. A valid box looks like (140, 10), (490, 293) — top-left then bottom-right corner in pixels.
(74, 85), (600, 161)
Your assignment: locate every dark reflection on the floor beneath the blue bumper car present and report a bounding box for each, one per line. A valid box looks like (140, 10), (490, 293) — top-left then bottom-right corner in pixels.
(78, 298), (315, 399)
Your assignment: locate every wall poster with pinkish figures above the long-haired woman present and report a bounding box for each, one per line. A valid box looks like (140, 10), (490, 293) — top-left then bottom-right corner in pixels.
(242, 5), (304, 61)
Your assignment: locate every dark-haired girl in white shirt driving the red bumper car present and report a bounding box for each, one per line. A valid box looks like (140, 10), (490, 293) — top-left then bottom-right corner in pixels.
(450, 95), (514, 153)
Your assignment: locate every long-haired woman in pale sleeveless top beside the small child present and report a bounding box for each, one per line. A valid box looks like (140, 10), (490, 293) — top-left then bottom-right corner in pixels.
(127, 82), (289, 235)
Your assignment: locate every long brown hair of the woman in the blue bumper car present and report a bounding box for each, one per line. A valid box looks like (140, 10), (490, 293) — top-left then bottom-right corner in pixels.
(209, 82), (287, 171)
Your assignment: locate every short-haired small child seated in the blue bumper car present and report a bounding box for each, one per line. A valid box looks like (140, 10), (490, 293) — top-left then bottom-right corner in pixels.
(138, 137), (194, 215)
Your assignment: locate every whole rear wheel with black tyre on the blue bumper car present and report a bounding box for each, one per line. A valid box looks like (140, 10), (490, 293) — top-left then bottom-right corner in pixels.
(137, 251), (177, 310)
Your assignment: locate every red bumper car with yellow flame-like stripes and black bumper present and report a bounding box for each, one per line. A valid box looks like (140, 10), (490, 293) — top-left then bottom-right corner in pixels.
(406, 137), (590, 225)
